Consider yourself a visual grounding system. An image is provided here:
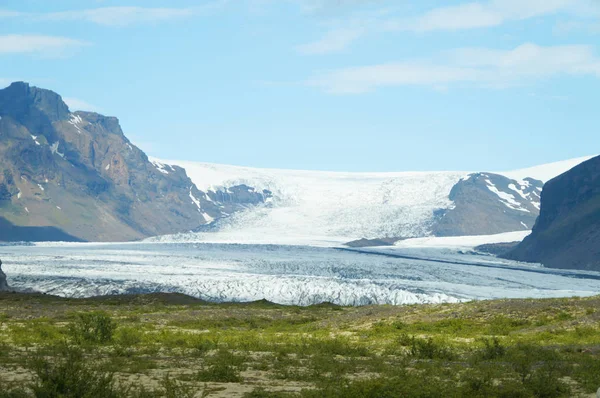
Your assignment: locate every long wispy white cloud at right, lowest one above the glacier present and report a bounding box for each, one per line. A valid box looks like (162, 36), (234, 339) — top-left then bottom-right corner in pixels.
(305, 43), (600, 94)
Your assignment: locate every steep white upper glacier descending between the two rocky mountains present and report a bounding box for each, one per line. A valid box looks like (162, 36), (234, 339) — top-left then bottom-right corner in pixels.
(154, 161), (465, 245)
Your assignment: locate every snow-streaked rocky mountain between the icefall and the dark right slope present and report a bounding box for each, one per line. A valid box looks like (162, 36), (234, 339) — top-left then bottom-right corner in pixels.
(432, 173), (544, 236)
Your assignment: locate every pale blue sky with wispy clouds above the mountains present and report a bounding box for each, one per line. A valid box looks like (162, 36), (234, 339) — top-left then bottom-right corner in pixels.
(0, 0), (600, 171)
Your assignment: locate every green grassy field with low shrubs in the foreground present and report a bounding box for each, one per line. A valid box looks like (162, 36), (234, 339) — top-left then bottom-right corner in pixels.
(0, 293), (600, 398)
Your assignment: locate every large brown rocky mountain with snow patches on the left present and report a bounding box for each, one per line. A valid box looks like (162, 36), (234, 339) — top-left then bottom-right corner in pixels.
(0, 82), (268, 241)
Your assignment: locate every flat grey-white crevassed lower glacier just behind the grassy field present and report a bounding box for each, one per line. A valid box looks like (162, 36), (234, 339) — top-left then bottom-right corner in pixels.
(0, 238), (600, 305)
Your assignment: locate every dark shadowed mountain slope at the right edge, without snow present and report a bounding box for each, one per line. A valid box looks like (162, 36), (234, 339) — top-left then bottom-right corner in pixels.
(506, 157), (600, 271)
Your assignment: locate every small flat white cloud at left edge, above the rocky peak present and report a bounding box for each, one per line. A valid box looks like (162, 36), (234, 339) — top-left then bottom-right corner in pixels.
(0, 35), (88, 56)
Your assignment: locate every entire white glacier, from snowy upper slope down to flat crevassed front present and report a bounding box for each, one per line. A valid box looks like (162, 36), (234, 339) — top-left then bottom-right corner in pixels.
(0, 159), (600, 305)
